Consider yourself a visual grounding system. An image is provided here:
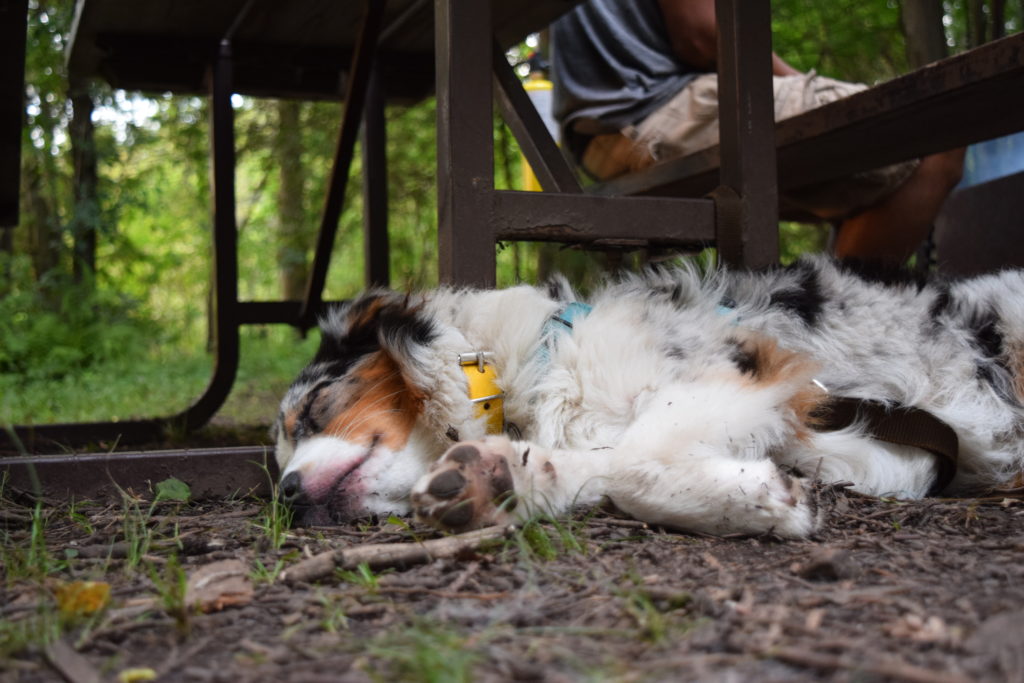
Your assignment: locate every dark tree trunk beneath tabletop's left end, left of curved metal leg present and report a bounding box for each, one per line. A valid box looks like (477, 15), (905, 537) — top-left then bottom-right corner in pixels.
(69, 83), (99, 285)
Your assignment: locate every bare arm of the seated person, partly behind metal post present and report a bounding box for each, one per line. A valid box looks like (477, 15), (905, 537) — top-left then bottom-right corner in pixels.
(658, 0), (800, 76)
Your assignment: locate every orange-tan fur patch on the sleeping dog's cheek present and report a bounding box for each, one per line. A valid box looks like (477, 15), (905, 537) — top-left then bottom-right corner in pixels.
(324, 351), (426, 451)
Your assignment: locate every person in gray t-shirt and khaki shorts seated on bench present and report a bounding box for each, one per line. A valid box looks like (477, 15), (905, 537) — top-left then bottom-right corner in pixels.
(552, 0), (964, 264)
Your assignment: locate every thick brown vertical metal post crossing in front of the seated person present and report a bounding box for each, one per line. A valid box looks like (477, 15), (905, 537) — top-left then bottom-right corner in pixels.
(715, 0), (778, 267)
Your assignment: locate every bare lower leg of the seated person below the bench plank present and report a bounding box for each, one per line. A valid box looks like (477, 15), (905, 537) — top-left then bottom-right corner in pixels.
(835, 148), (965, 265)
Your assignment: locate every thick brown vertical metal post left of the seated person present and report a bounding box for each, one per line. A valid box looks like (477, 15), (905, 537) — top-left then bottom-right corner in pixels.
(434, 0), (496, 287)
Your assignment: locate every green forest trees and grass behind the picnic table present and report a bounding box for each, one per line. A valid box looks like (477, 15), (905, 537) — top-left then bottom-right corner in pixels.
(0, 0), (1024, 427)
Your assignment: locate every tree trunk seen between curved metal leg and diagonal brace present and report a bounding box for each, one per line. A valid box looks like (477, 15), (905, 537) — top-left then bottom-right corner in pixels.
(274, 99), (311, 301)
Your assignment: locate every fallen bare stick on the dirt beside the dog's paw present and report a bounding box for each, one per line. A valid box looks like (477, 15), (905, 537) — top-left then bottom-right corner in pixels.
(281, 526), (515, 584)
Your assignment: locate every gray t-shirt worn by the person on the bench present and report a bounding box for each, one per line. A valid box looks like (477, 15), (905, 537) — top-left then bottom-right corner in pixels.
(551, 0), (698, 157)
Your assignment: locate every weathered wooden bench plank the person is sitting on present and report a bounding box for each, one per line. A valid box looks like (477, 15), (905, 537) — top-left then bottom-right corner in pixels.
(590, 34), (1024, 210)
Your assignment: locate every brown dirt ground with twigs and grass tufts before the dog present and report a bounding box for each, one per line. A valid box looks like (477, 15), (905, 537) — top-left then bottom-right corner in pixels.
(0, 481), (1024, 683)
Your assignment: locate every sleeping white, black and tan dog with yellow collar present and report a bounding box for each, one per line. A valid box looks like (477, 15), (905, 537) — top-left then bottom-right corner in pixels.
(275, 258), (1024, 538)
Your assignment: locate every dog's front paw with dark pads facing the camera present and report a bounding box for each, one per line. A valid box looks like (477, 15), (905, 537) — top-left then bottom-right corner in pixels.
(412, 438), (516, 531)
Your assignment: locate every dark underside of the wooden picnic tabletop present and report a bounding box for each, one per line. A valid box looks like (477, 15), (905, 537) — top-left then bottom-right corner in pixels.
(69, 0), (579, 99)
